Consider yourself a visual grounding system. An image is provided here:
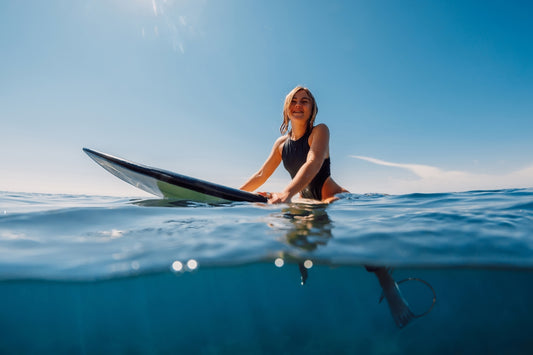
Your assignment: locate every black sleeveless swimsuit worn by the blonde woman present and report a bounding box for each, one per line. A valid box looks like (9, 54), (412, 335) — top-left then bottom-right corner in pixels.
(281, 129), (331, 200)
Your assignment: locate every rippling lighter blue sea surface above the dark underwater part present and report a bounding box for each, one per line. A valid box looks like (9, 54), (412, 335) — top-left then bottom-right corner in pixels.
(0, 189), (533, 279)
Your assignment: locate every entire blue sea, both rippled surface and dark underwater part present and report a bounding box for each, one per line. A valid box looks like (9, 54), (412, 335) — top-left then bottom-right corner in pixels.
(0, 189), (533, 354)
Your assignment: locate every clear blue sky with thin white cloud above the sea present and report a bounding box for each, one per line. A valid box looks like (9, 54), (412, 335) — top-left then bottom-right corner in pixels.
(0, 0), (533, 196)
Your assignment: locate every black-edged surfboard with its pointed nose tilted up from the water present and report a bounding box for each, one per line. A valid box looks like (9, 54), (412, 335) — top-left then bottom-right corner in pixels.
(83, 148), (267, 203)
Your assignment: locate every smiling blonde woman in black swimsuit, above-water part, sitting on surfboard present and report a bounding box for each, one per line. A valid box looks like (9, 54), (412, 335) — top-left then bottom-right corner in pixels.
(241, 86), (347, 203)
